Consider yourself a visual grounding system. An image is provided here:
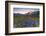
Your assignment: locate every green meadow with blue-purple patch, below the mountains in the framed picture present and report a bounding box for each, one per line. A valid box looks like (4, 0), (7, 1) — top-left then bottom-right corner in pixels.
(14, 16), (39, 27)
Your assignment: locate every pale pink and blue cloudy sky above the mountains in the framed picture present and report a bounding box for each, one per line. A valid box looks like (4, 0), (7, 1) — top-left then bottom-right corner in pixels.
(13, 8), (39, 14)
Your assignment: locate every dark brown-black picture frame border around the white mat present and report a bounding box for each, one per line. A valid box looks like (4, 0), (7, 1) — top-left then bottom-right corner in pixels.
(5, 1), (45, 35)
